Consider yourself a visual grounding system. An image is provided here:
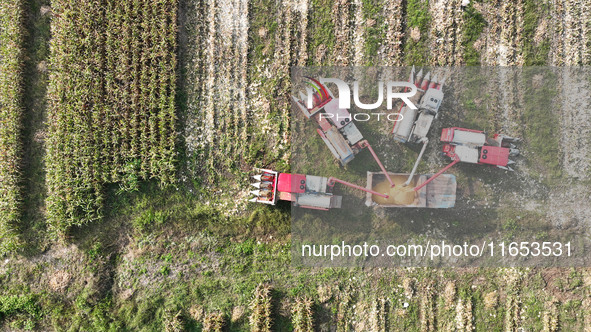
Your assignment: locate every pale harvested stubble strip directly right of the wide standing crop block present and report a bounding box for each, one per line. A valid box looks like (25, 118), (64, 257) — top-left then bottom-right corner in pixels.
(185, 0), (250, 184)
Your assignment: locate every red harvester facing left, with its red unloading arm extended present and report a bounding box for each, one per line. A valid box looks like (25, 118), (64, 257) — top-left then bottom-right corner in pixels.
(250, 169), (388, 210)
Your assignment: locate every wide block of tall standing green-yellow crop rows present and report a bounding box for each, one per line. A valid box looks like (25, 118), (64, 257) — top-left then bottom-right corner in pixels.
(46, 0), (176, 231)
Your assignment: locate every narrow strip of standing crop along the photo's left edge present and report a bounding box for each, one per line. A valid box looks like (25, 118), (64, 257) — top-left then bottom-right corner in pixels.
(0, 0), (23, 254)
